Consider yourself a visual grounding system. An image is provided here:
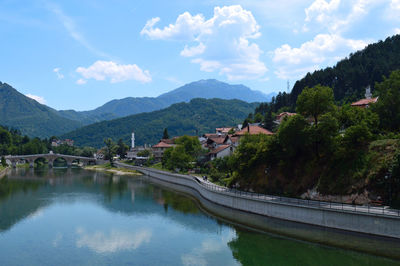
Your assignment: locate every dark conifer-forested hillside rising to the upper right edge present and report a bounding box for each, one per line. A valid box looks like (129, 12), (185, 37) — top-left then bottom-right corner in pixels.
(290, 35), (400, 105)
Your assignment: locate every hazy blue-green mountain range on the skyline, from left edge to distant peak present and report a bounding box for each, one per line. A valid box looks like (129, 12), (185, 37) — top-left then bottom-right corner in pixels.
(0, 80), (272, 138)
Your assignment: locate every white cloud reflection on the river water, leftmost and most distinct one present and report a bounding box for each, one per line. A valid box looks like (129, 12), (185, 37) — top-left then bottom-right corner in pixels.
(76, 228), (152, 253)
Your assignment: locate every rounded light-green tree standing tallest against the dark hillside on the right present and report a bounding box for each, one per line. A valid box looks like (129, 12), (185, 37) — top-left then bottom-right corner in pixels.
(297, 85), (334, 126)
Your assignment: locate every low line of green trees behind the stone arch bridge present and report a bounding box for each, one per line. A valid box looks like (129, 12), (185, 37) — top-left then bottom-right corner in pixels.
(0, 126), (96, 157)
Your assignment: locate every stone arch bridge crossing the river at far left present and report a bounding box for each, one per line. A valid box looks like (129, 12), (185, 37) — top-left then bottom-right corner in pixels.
(5, 153), (96, 168)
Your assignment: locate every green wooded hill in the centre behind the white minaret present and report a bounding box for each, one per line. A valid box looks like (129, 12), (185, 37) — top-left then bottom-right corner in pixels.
(62, 98), (258, 147)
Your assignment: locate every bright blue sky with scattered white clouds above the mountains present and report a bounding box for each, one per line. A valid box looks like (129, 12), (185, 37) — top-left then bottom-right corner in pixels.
(0, 0), (400, 111)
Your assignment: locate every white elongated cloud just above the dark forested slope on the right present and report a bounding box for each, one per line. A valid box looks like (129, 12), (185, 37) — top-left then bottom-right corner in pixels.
(273, 34), (367, 79)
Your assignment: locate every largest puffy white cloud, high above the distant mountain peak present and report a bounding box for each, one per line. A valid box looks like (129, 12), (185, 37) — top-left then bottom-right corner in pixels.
(141, 5), (267, 80)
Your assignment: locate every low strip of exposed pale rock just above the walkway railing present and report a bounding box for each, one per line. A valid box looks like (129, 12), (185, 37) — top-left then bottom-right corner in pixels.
(301, 189), (371, 205)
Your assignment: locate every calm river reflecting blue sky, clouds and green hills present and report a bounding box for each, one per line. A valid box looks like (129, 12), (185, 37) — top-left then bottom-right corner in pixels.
(0, 168), (400, 266)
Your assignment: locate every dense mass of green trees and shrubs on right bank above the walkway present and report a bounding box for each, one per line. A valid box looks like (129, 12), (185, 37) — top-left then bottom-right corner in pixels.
(219, 71), (400, 208)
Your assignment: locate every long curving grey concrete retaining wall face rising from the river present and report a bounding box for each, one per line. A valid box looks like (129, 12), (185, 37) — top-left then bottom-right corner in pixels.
(119, 165), (400, 239)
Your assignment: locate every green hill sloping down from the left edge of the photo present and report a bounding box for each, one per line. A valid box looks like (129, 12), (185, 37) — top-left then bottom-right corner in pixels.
(0, 82), (81, 137)
